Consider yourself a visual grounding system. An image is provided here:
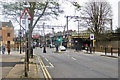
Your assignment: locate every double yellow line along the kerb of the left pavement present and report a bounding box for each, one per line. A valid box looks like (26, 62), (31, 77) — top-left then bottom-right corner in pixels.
(38, 56), (52, 80)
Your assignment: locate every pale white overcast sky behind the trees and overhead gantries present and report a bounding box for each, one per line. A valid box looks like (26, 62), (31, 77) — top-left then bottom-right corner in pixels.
(0, 0), (120, 33)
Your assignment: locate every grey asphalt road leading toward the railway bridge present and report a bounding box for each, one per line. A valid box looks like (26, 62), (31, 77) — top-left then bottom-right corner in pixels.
(34, 48), (118, 78)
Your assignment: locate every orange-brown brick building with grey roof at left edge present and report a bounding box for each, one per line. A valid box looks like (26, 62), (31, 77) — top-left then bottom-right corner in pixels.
(0, 21), (14, 45)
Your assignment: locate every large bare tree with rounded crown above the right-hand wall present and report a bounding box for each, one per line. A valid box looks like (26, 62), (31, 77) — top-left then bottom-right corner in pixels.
(82, 1), (112, 40)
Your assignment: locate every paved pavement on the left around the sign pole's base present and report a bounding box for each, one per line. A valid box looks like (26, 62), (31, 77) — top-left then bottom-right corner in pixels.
(0, 50), (41, 80)
